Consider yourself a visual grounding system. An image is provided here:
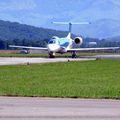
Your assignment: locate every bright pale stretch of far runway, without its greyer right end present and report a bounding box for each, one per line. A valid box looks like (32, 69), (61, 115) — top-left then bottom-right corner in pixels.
(0, 57), (95, 65)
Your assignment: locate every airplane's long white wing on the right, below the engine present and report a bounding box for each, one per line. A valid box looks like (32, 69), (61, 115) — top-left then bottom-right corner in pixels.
(67, 47), (120, 52)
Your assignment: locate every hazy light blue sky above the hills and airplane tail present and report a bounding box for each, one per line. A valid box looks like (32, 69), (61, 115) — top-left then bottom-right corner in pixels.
(0, 0), (120, 37)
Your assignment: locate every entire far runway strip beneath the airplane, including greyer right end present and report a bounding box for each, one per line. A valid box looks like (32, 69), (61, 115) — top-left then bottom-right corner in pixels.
(0, 55), (120, 65)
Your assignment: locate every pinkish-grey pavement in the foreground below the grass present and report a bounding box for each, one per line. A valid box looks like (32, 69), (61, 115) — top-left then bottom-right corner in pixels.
(0, 97), (120, 120)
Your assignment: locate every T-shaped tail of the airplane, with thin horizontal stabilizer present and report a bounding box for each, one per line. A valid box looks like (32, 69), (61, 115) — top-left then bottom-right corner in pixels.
(53, 22), (91, 37)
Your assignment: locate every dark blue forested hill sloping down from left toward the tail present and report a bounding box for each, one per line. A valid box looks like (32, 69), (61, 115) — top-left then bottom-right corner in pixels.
(0, 20), (67, 41)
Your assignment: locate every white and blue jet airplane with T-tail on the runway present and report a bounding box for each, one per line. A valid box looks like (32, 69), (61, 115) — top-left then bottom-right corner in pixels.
(9, 22), (119, 58)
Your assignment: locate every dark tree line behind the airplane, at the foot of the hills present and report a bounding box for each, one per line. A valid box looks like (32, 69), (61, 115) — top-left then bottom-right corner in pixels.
(0, 38), (120, 50)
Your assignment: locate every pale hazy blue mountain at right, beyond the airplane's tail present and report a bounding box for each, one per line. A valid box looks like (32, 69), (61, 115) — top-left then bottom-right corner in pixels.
(76, 19), (120, 38)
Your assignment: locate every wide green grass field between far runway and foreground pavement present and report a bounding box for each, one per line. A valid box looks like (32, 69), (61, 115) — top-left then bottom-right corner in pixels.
(0, 60), (120, 99)
